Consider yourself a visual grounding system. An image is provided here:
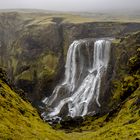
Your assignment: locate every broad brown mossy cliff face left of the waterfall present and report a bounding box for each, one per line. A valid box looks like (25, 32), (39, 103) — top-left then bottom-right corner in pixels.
(0, 13), (63, 104)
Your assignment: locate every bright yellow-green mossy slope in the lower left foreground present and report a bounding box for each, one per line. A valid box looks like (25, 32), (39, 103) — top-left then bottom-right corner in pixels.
(0, 69), (68, 140)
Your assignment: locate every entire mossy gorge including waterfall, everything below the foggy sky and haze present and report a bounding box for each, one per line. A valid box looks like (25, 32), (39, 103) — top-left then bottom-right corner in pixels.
(0, 10), (140, 140)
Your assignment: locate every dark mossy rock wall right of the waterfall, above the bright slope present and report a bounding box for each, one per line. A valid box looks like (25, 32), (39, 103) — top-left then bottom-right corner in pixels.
(110, 32), (140, 105)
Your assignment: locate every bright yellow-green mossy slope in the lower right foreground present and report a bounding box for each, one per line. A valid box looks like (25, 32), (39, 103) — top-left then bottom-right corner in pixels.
(70, 88), (140, 140)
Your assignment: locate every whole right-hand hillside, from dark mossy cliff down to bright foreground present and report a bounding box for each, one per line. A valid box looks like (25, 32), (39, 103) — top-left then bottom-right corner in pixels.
(59, 32), (140, 140)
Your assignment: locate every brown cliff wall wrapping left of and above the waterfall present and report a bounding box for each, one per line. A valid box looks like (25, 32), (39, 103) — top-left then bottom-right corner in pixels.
(0, 12), (140, 103)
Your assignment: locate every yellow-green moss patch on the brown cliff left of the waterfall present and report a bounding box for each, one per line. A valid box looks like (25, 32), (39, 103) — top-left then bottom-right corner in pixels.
(15, 52), (58, 81)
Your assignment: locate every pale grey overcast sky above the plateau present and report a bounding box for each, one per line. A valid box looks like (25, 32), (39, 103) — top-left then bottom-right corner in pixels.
(0, 0), (140, 11)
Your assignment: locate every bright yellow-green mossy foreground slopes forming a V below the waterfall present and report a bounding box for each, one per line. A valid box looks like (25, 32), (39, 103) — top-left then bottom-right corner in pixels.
(0, 66), (140, 140)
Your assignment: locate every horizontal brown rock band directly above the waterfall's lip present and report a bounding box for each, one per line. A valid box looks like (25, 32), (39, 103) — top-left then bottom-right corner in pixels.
(63, 22), (140, 54)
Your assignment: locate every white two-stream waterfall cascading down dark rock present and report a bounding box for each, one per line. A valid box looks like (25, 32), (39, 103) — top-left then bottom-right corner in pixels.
(42, 39), (111, 120)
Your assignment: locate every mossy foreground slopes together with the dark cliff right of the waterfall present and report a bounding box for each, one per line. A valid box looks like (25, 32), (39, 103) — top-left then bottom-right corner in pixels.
(0, 29), (140, 140)
